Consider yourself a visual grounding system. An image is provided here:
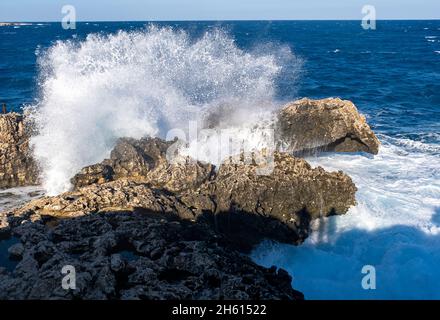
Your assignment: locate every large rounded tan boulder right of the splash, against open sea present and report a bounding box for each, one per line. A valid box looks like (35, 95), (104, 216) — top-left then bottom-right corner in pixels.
(278, 98), (380, 154)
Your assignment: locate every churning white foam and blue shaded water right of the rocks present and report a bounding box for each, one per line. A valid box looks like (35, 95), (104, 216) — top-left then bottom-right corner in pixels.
(252, 135), (440, 299)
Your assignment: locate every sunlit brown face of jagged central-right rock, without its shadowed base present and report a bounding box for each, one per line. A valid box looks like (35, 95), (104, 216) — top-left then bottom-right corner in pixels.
(203, 152), (357, 222)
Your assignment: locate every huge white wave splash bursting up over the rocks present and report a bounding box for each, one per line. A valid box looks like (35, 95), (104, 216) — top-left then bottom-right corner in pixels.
(31, 26), (295, 195)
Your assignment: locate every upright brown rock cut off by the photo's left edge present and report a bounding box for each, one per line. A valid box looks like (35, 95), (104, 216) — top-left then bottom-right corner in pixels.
(0, 113), (38, 188)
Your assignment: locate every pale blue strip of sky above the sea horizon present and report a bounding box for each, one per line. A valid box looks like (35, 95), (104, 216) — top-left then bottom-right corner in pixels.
(0, 0), (440, 21)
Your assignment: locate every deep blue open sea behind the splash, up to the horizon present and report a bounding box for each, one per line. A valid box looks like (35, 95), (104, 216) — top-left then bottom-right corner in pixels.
(0, 20), (440, 142)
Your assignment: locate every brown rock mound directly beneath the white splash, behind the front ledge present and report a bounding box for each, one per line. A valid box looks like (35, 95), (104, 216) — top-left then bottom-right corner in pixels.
(72, 138), (214, 192)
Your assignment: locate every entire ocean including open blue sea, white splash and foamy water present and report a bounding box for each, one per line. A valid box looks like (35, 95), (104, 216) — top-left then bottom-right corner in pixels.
(0, 20), (440, 299)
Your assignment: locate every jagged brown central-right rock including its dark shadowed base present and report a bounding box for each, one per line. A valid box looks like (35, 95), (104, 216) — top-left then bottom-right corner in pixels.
(199, 152), (357, 250)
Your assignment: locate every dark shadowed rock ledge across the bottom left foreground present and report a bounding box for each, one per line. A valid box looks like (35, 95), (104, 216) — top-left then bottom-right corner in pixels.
(0, 212), (303, 300)
